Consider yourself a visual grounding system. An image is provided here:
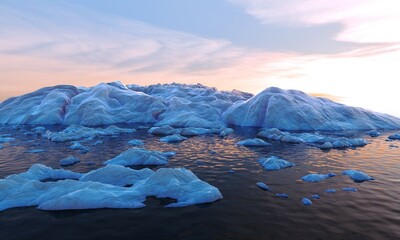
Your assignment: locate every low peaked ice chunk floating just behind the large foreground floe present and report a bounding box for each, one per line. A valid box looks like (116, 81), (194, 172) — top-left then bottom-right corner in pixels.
(104, 148), (169, 166)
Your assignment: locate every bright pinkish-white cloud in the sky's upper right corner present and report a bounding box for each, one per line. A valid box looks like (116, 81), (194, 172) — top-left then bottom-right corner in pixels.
(231, 0), (400, 43)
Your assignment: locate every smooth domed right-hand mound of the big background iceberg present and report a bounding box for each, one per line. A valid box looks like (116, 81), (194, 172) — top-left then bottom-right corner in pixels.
(223, 87), (400, 131)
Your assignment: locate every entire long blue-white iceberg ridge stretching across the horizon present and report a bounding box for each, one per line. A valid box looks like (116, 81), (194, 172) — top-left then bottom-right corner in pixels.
(0, 82), (400, 131)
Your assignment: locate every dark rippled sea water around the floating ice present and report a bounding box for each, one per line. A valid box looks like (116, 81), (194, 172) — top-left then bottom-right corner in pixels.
(0, 125), (400, 240)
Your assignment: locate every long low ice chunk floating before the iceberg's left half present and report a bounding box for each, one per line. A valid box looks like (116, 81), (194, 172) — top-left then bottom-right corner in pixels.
(46, 124), (136, 142)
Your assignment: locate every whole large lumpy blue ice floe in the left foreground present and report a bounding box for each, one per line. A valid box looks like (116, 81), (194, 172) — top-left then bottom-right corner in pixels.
(0, 164), (222, 210)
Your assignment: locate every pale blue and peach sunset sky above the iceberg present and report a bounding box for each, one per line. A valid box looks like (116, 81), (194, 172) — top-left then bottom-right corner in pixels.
(0, 0), (400, 117)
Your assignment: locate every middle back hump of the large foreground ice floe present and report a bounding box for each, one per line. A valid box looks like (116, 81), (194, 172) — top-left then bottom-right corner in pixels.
(79, 165), (154, 187)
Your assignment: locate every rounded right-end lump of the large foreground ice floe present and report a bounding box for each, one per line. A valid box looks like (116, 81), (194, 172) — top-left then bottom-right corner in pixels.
(134, 168), (222, 207)
